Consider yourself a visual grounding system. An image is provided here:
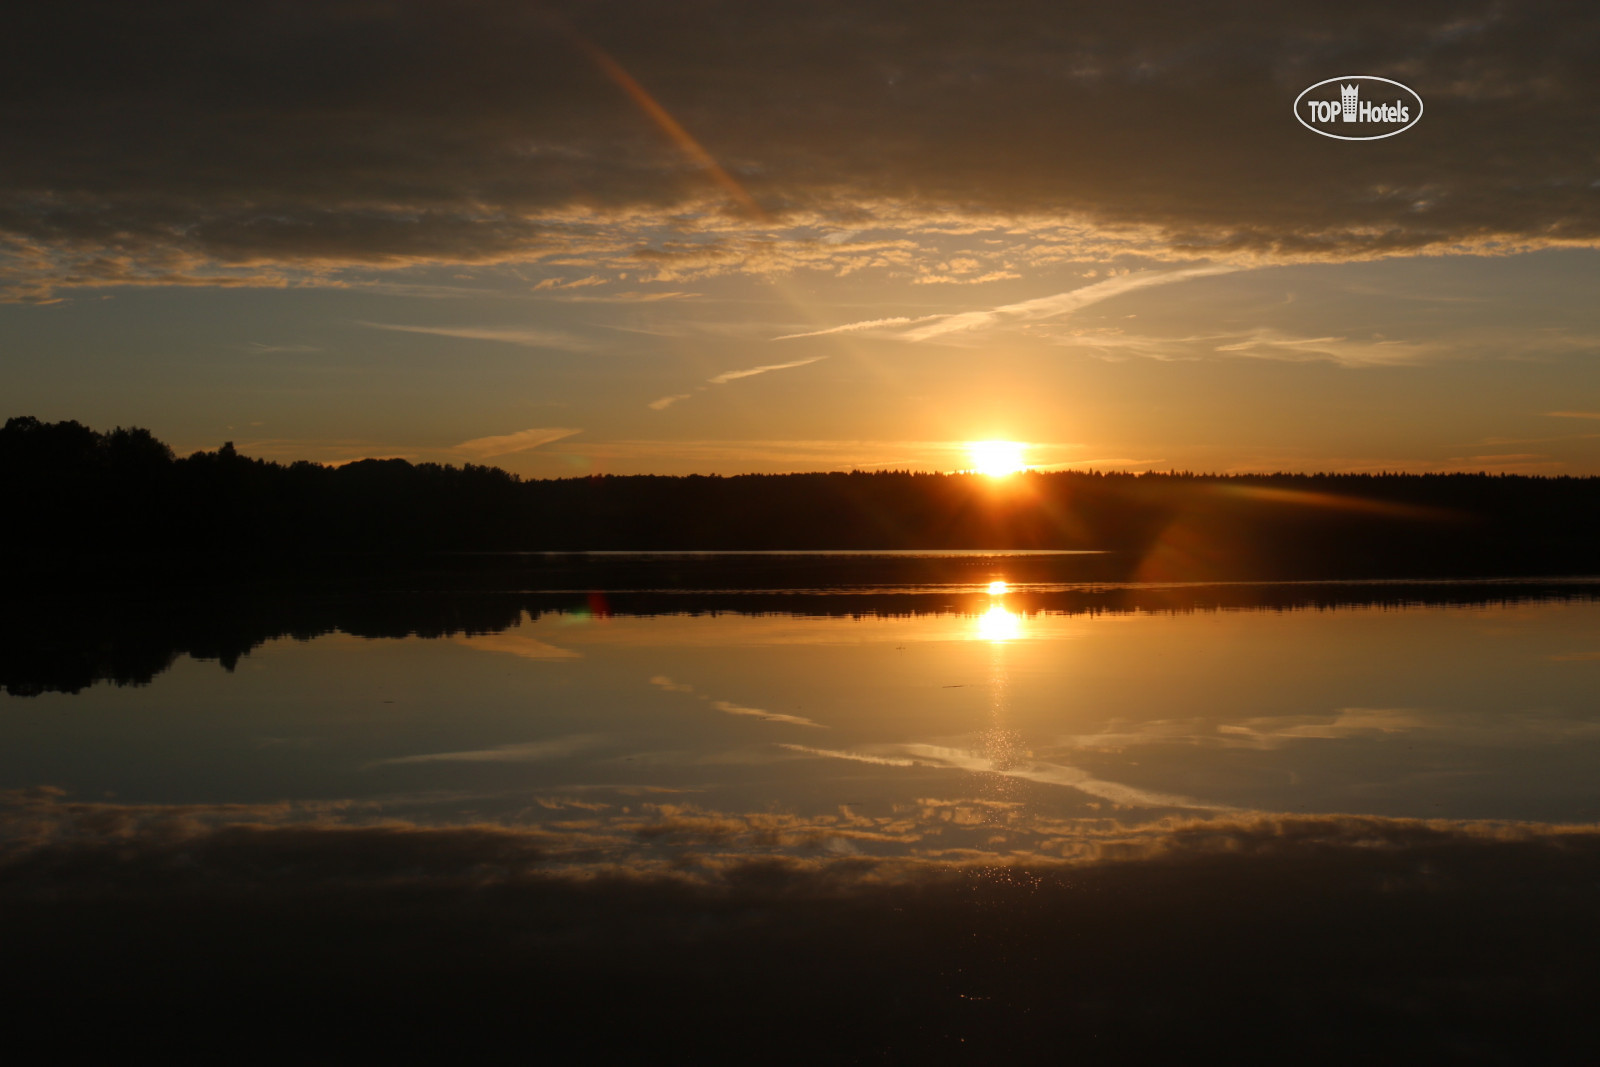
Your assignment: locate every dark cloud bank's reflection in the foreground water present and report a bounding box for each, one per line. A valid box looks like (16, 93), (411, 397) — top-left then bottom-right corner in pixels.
(9, 797), (1600, 1062)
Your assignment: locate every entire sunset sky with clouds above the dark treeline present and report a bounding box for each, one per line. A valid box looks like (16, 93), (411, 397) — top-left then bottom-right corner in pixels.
(0, 0), (1600, 477)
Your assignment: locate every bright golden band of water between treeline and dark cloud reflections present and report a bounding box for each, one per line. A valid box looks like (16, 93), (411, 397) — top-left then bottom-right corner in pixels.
(12, 587), (1600, 862)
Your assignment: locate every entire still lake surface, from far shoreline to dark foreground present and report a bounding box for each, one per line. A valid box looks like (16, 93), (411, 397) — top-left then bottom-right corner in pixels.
(9, 560), (1600, 1062)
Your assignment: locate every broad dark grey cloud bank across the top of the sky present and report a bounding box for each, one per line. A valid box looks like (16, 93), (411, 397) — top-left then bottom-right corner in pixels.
(0, 0), (1600, 299)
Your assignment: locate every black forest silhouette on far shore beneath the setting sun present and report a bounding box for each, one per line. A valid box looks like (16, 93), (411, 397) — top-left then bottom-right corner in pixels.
(9, 416), (1600, 582)
